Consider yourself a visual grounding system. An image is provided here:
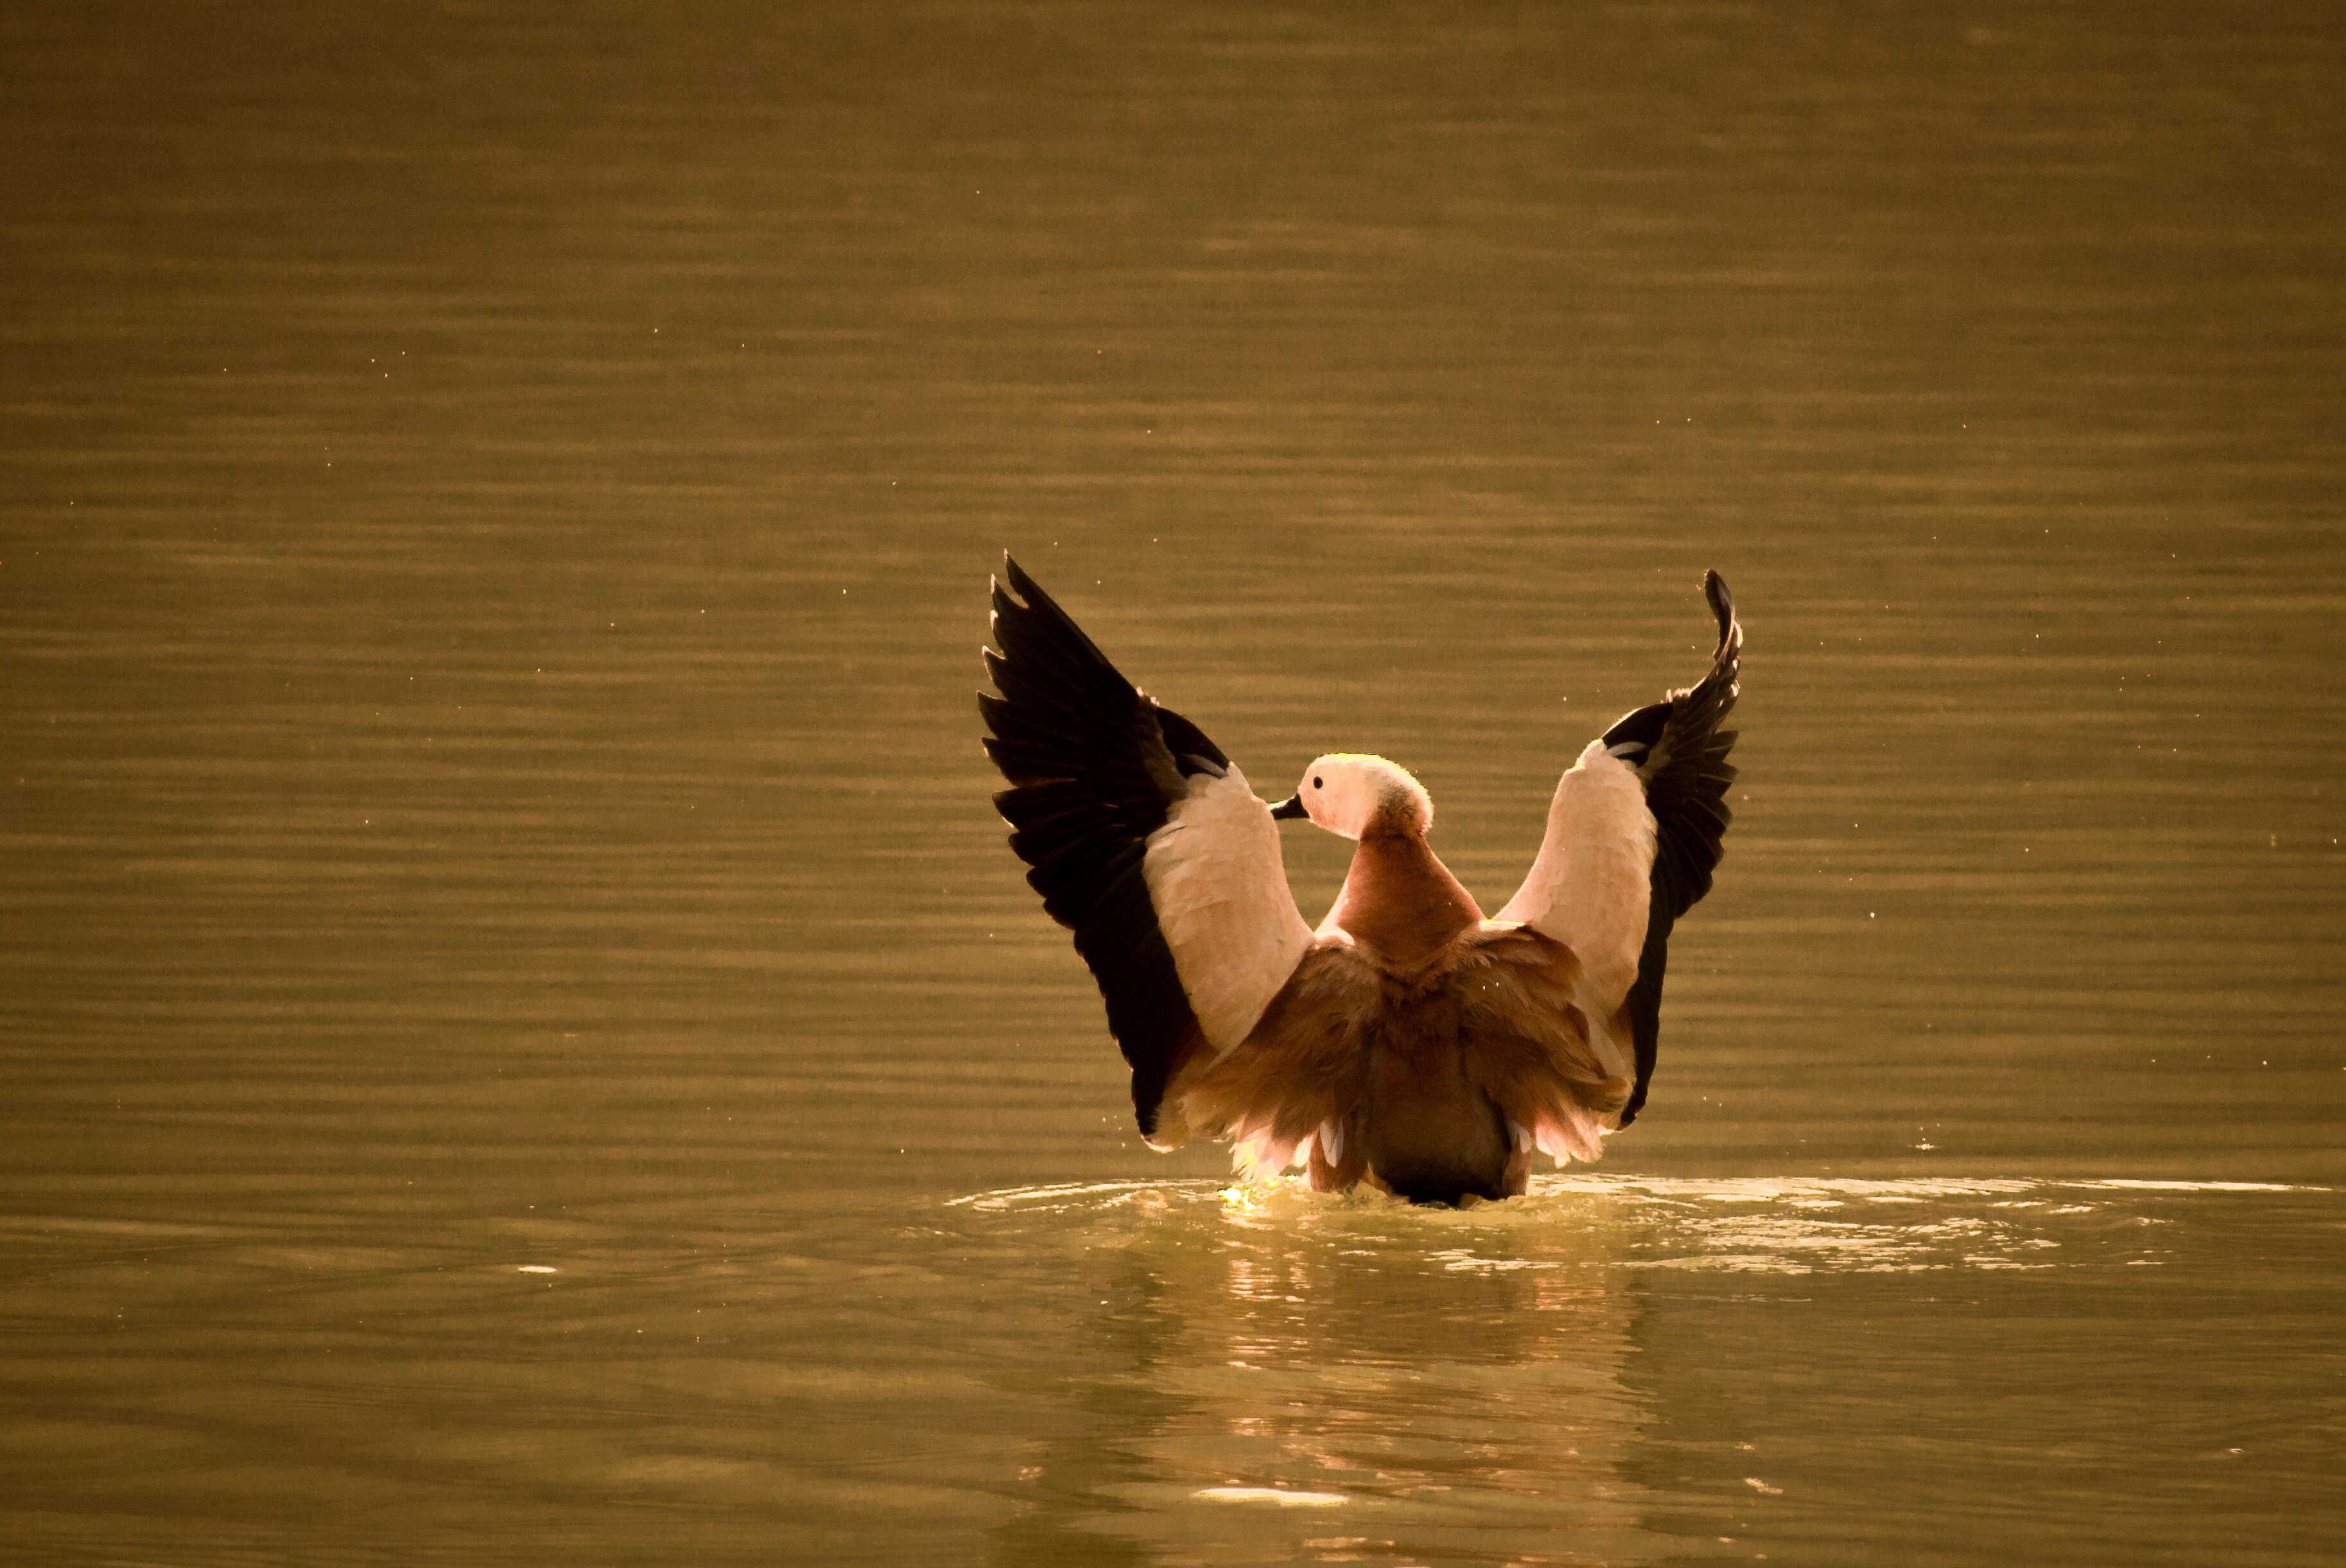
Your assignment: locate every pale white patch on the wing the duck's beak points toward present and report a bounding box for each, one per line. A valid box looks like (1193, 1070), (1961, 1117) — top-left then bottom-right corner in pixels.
(1140, 765), (1323, 1054)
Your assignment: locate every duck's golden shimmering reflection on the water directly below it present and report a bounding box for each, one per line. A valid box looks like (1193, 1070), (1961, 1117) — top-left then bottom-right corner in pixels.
(966, 1183), (1661, 1561)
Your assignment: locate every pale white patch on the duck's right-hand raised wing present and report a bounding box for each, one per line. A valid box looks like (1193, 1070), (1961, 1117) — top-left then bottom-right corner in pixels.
(1497, 740), (1654, 1018)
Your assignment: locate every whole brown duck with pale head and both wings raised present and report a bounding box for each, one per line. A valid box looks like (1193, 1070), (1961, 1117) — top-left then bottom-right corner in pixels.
(978, 552), (1743, 1206)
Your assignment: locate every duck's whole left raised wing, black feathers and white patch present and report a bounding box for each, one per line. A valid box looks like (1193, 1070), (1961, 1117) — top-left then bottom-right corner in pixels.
(978, 556), (1312, 1146)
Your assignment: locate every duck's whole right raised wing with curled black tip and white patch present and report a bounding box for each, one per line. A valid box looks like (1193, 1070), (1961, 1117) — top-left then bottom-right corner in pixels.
(1497, 573), (1743, 1127)
